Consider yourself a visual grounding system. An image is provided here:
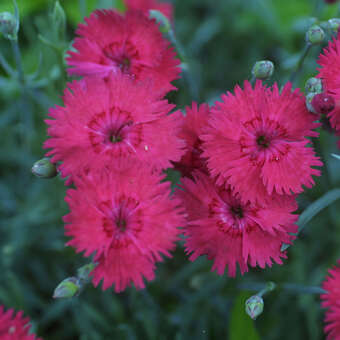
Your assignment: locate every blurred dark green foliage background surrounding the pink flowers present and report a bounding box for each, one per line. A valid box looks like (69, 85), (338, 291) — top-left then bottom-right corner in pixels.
(0, 0), (340, 340)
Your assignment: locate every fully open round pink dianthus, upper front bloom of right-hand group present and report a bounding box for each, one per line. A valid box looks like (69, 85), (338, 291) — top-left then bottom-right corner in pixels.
(200, 81), (322, 202)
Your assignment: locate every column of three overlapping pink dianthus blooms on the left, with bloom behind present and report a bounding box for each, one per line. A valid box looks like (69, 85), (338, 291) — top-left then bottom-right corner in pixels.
(44, 1), (185, 292)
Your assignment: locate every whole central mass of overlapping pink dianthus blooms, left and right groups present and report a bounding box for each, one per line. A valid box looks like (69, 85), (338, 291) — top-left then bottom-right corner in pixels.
(44, 0), (322, 292)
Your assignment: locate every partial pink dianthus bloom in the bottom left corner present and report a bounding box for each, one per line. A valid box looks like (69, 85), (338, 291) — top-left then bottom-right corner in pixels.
(0, 306), (42, 340)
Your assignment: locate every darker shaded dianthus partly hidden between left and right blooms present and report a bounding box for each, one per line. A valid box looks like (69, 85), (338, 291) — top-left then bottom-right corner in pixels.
(175, 102), (209, 177)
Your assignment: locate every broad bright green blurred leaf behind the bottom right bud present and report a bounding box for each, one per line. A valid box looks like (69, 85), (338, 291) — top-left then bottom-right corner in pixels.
(229, 292), (260, 340)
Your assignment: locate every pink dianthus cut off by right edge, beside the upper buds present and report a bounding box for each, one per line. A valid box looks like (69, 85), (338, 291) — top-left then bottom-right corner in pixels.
(317, 35), (340, 132)
